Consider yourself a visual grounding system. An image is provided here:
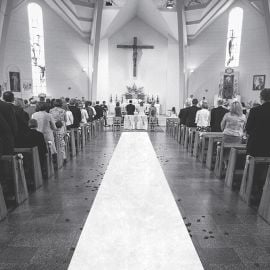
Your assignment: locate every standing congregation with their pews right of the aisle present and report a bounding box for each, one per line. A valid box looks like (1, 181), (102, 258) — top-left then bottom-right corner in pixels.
(166, 89), (270, 222)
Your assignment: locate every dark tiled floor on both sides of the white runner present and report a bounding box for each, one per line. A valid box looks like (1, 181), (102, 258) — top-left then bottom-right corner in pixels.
(0, 132), (270, 270)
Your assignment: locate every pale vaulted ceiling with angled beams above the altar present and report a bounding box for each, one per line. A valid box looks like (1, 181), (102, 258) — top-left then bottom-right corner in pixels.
(42, 0), (263, 40)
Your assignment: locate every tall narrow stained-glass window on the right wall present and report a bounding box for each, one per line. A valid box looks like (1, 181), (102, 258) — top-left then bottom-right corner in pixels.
(225, 7), (243, 68)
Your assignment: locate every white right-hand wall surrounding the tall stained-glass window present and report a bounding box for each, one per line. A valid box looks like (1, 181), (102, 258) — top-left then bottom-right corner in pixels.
(187, 0), (270, 103)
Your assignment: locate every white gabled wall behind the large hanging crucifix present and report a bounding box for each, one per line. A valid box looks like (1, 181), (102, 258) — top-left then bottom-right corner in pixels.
(98, 17), (179, 112)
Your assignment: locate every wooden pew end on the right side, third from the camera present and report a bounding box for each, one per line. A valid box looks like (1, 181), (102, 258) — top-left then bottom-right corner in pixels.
(225, 147), (246, 189)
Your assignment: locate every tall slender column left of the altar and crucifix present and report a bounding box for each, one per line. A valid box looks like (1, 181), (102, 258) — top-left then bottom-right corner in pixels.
(90, 0), (104, 101)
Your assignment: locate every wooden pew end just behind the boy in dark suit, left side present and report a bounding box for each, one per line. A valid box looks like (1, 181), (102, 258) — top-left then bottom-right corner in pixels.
(14, 146), (43, 190)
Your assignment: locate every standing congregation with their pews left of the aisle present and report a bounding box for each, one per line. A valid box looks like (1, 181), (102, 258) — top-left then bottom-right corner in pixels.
(0, 91), (106, 220)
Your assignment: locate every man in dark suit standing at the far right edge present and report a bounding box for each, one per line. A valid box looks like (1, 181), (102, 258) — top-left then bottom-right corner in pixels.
(246, 88), (270, 157)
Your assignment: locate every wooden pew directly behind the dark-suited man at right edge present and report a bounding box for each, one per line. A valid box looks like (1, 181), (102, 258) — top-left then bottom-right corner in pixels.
(240, 156), (270, 204)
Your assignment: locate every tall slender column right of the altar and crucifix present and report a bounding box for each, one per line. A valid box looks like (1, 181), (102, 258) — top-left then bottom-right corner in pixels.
(176, 0), (187, 108)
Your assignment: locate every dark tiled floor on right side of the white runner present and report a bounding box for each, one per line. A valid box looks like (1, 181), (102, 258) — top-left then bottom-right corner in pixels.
(150, 133), (270, 270)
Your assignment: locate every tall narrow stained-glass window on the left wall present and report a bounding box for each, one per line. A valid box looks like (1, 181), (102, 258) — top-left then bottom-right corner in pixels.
(28, 3), (47, 96)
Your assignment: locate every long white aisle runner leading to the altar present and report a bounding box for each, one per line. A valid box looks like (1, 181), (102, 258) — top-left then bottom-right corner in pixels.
(69, 132), (203, 270)
